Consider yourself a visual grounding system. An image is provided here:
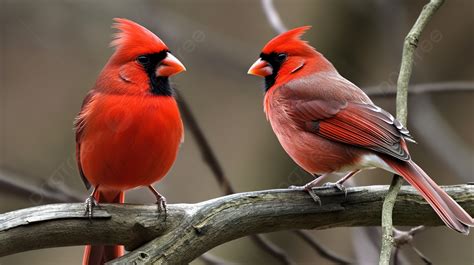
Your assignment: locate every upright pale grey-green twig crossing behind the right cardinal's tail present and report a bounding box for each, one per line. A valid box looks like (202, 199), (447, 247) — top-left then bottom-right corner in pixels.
(379, 0), (444, 265)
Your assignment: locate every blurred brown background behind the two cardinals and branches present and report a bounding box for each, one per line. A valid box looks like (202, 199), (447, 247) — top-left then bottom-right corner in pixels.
(0, 0), (474, 265)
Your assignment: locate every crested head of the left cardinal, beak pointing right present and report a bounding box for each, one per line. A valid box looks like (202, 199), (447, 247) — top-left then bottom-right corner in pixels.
(98, 18), (186, 96)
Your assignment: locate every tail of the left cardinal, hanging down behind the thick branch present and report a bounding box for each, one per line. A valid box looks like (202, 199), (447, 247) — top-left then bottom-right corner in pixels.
(82, 192), (125, 265)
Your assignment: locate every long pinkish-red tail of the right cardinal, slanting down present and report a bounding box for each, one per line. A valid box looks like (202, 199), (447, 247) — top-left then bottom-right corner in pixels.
(384, 158), (474, 234)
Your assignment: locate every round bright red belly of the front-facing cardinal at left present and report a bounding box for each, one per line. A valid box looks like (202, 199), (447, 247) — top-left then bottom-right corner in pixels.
(81, 95), (183, 190)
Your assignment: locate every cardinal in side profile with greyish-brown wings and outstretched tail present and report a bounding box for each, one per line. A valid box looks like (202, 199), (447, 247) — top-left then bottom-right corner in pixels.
(248, 27), (474, 234)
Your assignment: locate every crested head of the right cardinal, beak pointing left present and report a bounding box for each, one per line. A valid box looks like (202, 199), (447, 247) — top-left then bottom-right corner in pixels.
(248, 26), (334, 91)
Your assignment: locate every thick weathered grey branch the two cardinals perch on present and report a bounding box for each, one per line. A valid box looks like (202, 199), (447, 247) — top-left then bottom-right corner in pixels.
(0, 185), (474, 264)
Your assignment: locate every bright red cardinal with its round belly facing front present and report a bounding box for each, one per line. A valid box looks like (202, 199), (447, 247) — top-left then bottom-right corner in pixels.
(76, 19), (185, 264)
